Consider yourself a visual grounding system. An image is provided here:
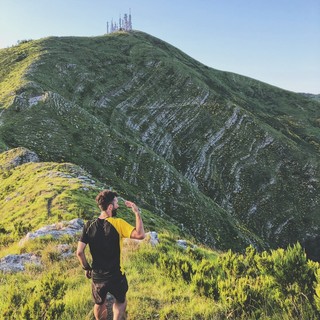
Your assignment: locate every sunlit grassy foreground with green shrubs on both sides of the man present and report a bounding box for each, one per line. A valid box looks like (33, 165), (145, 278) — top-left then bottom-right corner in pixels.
(0, 232), (320, 320)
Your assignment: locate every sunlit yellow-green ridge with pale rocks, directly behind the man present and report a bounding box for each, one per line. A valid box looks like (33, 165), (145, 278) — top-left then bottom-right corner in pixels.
(0, 148), (183, 245)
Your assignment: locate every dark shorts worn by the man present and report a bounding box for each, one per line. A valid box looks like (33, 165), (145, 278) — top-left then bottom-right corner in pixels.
(92, 274), (128, 305)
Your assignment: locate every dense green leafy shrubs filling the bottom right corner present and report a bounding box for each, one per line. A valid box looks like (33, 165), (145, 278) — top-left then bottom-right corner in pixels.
(158, 243), (320, 319)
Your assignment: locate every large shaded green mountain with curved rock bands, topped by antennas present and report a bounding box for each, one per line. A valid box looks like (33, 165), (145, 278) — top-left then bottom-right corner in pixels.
(0, 32), (320, 253)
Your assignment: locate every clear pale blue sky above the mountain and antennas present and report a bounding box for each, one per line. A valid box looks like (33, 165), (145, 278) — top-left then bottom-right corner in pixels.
(0, 0), (320, 94)
